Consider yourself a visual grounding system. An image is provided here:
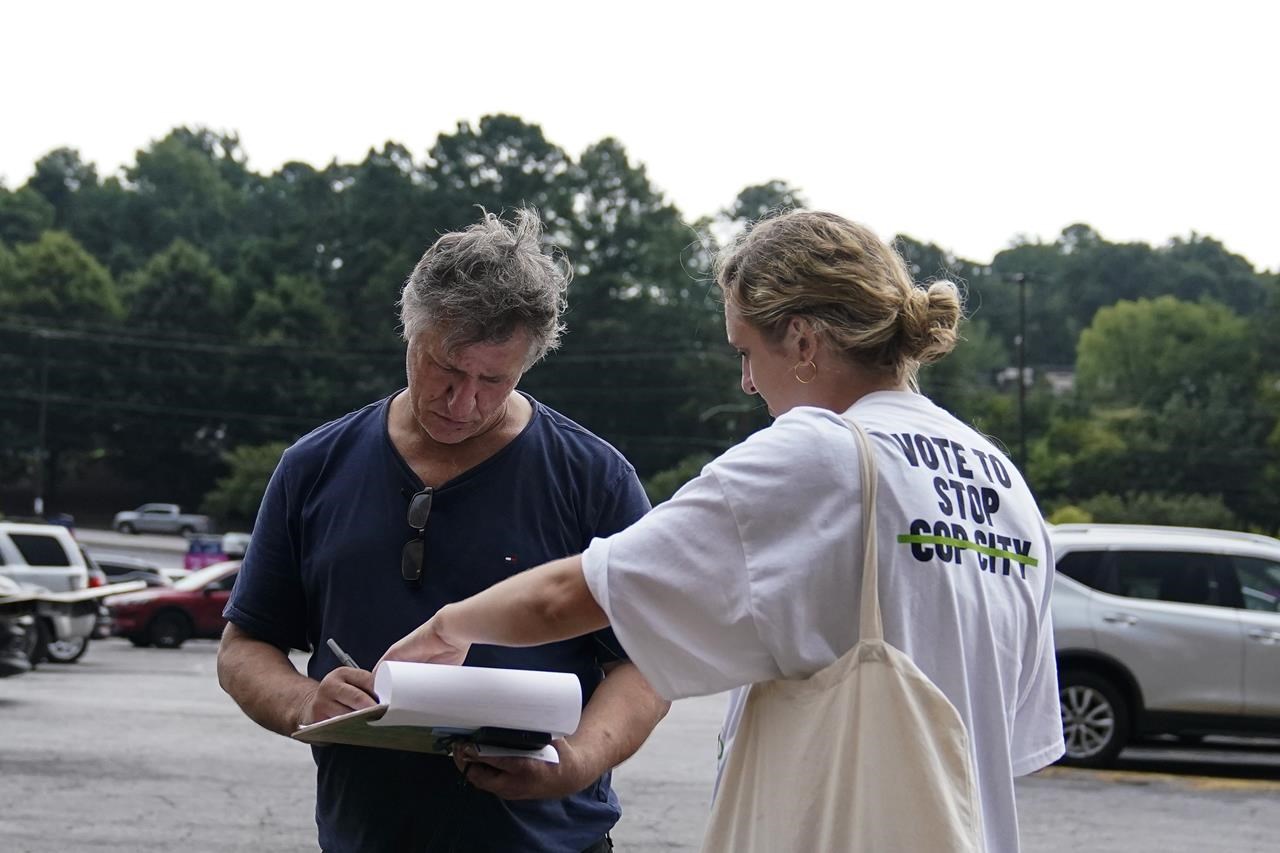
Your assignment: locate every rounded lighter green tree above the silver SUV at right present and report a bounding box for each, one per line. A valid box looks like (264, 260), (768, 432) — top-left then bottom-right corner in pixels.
(1032, 296), (1275, 523)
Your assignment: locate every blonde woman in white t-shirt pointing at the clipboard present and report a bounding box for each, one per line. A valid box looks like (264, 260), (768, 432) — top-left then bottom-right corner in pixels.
(387, 211), (1062, 852)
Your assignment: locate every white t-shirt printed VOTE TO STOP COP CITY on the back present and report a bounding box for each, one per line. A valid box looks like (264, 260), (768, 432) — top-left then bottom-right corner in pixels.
(582, 392), (1064, 853)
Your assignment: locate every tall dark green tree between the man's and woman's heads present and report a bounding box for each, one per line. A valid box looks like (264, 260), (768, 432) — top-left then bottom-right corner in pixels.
(529, 140), (741, 474)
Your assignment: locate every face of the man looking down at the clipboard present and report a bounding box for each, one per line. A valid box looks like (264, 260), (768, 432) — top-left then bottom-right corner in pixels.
(404, 329), (530, 444)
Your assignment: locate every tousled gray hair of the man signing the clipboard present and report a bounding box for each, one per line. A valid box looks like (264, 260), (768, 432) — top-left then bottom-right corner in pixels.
(399, 209), (572, 369)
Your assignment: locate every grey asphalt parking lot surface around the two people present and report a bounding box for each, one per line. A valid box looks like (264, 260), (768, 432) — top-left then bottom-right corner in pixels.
(0, 639), (1280, 853)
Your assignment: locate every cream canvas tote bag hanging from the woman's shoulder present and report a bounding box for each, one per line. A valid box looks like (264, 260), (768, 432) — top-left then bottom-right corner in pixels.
(703, 419), (983, 853)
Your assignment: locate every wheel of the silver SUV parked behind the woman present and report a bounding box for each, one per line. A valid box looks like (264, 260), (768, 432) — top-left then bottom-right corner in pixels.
(1057, 670), (1129, 767)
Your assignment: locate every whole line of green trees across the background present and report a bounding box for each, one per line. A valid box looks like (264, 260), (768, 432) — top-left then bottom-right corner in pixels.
(0, 115), (1280, 532)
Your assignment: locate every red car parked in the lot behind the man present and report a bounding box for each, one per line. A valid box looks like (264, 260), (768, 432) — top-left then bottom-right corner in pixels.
(106, 560), (239, 648)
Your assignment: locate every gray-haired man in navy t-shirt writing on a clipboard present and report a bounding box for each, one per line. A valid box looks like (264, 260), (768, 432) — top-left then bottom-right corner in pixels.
(218, 211), (668, 853)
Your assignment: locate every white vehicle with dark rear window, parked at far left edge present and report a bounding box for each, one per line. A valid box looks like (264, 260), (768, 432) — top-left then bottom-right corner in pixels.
(0, 521), (99, 663)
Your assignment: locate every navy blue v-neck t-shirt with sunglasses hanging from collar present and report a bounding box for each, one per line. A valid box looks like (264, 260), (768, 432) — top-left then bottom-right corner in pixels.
(225, 398), (649, 853)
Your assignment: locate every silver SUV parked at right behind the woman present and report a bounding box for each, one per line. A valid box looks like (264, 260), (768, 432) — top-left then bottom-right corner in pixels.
(1051, 524), (1280, 766)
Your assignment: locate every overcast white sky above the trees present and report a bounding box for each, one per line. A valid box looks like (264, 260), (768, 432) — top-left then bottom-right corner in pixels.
(0, 0), (1280, 270)
